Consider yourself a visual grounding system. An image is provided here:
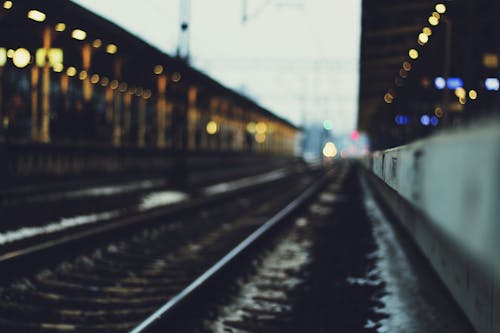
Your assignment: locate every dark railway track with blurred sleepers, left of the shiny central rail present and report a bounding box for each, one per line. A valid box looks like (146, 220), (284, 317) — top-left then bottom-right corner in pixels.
(0, 165), (324, 332)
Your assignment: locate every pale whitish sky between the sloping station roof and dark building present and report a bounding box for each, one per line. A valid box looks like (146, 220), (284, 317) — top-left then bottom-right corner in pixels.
(73, 0), (361, 132)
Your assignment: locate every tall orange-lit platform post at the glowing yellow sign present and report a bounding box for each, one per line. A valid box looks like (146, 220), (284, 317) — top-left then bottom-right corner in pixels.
(40, 26), (52, 143)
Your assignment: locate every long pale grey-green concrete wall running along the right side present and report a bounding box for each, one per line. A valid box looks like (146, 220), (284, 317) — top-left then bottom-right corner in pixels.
(363, 121), (500, 333)
